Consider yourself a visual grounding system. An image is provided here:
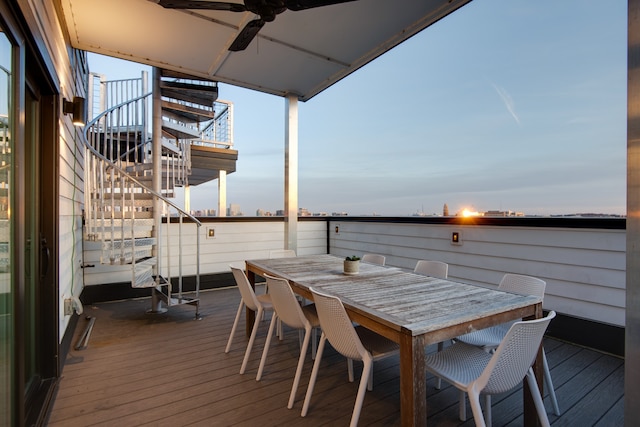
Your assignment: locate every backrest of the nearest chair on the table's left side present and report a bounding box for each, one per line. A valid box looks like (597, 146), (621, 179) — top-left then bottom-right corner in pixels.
(310, 288), (368, 360)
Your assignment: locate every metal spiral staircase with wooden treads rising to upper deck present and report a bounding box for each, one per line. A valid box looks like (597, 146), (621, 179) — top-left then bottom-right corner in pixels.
(84, 69), (237, 318)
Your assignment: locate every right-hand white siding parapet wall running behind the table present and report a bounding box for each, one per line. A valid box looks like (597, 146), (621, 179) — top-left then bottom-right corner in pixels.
(330, 221), (626, 326)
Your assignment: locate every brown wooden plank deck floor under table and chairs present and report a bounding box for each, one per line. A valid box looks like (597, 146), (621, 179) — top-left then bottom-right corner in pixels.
(47, 288), (624, 427)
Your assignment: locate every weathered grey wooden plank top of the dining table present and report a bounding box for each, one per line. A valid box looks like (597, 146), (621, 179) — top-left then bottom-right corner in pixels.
(247, 255), (542, 343)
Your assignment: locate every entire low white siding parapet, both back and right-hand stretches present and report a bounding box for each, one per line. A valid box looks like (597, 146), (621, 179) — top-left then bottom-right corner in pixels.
(85, 217), (626, 326)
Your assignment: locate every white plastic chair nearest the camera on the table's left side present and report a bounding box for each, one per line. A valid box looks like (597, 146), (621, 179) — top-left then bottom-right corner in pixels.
(301, 288), (399, 426)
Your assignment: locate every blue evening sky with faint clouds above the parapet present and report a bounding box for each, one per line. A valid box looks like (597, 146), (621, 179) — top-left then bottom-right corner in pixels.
(89, 0), (627, 216)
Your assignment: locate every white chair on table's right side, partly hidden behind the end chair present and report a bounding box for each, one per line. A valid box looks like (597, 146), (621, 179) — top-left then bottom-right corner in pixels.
(456, 273), (560, 421)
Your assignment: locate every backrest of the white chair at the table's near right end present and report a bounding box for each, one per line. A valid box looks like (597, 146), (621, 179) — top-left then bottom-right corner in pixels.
(476, 311), (556, 394)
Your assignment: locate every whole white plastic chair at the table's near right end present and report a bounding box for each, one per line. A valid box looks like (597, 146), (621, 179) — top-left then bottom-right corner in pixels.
(426, 311), (556, 427)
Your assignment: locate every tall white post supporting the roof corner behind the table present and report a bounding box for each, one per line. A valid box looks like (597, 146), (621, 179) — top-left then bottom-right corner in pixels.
(284, 95), (298, 252)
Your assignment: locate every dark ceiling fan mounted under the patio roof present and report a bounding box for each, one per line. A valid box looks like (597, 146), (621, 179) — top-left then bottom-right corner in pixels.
(155, 0), (355, 52)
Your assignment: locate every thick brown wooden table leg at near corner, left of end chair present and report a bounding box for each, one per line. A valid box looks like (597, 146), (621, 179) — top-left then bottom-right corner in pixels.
(400, 334), (427, 426)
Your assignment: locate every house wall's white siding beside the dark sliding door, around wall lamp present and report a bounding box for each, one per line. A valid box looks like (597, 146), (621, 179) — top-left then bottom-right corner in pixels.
(29, 1), (86, 339)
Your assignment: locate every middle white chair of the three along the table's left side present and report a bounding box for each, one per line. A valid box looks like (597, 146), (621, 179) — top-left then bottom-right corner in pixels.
(256, 275), (320, 409)
